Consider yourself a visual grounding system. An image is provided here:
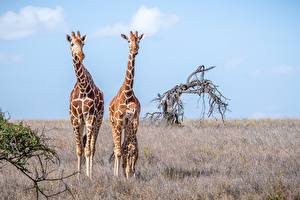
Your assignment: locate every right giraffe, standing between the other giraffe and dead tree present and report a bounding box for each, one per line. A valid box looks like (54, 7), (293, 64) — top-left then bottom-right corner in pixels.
(109, 31), (144, 178)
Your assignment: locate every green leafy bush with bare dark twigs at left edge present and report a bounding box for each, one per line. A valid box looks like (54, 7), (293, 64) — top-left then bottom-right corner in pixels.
(0, 110), (76, 199)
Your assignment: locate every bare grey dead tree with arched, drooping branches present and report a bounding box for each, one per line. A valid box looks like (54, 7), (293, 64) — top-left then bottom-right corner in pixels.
(145, 65), (229, 124)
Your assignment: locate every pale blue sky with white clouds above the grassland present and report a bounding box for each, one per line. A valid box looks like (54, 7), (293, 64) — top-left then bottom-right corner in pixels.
(0, 0), (300, 119)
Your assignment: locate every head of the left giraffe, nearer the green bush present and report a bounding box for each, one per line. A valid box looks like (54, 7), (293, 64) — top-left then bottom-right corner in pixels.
(67, 31), (86, 62)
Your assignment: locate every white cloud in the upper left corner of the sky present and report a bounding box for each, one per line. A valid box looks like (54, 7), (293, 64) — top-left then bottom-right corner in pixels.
(0, 6), (66, 40)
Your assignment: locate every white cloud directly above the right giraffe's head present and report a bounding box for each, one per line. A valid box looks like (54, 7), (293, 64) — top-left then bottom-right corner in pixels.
(95, 6), (179, 36)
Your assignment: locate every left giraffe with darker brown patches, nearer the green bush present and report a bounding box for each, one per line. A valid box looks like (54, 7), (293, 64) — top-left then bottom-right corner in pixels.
(67, 31), (104, 178)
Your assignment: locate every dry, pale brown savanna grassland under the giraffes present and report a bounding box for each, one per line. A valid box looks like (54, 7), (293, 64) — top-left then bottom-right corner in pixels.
(0, 120), (300, 200)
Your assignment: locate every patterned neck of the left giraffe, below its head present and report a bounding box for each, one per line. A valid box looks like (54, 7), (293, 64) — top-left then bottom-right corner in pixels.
(73, 56), (92, 93)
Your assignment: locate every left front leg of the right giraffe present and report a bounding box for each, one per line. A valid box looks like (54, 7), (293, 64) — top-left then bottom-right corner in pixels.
(113, 124), (122, 176)
